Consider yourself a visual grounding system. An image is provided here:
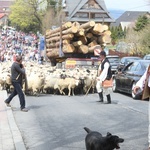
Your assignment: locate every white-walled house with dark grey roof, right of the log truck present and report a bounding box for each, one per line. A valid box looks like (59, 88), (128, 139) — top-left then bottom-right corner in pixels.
(111, 11), (150, 30)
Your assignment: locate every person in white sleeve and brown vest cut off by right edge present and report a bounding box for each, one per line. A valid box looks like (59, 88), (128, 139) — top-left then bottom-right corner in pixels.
(133, 65), (150, 150)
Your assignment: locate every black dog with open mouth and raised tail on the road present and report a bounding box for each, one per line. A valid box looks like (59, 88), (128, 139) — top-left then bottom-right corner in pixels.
(84, 127), (124, 150)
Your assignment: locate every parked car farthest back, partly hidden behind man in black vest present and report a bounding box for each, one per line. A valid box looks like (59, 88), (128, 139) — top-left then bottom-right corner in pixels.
(106, 55), (120, 74)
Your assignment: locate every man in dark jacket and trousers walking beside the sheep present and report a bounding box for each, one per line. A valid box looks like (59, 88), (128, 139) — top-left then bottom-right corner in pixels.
(5, 56), (28, 112)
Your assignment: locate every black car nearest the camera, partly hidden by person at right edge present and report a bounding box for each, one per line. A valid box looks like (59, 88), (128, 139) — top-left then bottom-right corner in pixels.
(113, 60), (150, 99)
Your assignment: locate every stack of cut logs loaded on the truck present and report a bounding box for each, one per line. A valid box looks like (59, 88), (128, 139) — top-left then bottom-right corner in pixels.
(46, 21), (111, 58)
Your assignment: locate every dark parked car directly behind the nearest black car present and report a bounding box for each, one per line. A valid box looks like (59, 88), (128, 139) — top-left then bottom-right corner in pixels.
(117, 56), (142, 71)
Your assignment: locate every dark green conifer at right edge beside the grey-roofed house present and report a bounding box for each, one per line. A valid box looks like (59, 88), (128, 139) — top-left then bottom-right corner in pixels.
(134, 15), (149, 31)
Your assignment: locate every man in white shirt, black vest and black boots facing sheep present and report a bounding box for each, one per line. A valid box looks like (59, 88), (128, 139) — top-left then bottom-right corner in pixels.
(96, 51), (112, 104)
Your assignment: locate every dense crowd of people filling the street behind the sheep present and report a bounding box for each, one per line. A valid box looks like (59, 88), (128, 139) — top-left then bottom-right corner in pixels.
(0, 28), (44, 62)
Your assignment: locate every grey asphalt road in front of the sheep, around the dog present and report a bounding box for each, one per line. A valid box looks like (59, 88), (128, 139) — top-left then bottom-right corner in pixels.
(12, 93), (148, 150)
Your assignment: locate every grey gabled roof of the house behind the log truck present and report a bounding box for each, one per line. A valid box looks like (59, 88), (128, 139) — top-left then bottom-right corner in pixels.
(63, 0), (114, 22)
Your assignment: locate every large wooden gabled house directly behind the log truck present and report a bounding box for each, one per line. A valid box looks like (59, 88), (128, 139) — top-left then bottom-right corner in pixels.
(62, 0), (114, 25)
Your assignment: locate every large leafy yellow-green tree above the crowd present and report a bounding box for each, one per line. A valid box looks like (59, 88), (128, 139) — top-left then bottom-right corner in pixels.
(9, 0), (44, 32)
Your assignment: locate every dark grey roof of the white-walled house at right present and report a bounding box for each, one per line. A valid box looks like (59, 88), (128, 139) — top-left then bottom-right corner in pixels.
(111, 11), (149, 26)
